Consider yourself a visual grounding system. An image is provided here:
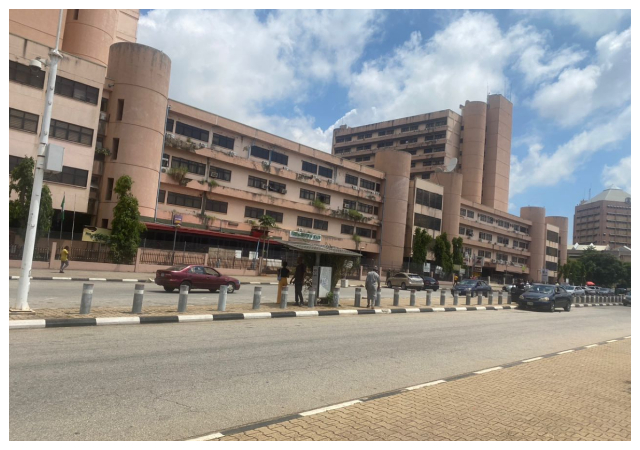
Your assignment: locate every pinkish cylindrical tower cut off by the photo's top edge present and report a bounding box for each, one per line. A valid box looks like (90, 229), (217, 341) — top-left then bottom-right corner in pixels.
(62, 9), (118, 66)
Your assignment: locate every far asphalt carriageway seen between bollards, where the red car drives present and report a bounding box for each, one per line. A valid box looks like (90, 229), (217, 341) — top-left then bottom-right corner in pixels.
(9, 280), (452, 309)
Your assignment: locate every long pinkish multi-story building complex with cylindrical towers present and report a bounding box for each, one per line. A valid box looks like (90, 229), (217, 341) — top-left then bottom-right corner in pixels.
(9, 10), (567, 280)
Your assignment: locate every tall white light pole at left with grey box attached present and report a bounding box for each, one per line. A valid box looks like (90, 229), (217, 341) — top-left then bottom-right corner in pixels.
(11, 9), (64, 311)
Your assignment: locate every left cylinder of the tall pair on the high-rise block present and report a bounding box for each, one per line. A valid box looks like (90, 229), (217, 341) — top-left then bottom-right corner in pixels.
(460, 101), (487, 203)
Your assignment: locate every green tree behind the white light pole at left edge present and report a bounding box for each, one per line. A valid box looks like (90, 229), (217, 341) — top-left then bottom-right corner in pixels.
(9, 157), (53, 239)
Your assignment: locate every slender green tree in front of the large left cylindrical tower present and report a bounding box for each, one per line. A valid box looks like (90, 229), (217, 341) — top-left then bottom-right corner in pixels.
(109, 175), (146, 264)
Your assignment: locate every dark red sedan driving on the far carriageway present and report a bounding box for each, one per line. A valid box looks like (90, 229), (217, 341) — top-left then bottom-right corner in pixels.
(155, 265), (240, 294)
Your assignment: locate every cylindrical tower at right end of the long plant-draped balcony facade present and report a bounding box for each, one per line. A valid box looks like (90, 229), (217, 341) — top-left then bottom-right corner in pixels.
(374, 150), (411, 270)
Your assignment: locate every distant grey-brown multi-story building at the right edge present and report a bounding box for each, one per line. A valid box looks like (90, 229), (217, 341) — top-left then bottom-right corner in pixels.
(573, 188), (631, 248)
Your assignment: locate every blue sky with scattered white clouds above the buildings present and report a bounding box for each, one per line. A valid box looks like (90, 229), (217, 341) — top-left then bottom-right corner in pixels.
(138, 9), (631, 244)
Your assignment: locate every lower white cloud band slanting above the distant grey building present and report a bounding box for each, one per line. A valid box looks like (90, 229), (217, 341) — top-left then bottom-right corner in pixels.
(509, 106), (631, 197)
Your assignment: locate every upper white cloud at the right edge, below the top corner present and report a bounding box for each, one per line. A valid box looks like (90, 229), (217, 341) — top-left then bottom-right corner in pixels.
(531, 29), (631, 127)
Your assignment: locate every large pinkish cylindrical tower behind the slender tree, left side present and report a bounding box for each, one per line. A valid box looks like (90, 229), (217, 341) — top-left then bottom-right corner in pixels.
(98, 42), (171, 224)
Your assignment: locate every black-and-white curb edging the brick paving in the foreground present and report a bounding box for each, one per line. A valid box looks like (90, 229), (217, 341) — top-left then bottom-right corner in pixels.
(185, 336), (631, 441)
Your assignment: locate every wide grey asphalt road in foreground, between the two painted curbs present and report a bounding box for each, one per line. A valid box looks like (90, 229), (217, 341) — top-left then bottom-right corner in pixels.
(9, 306), (631, 440)
